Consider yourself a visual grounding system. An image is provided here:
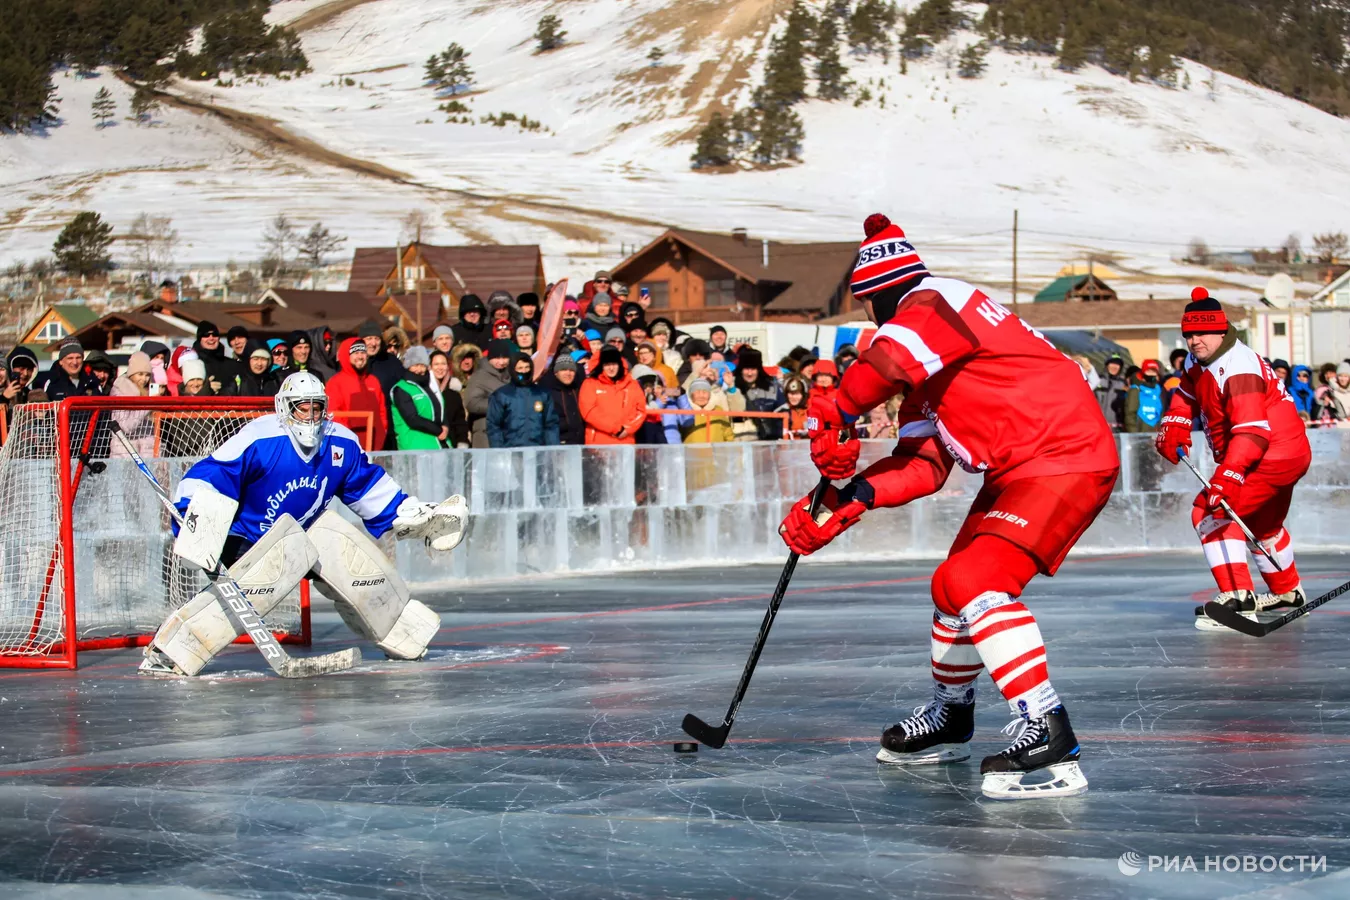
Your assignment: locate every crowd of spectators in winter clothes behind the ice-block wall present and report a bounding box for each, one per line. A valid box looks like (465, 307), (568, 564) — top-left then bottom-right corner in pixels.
(18, 271), (1350, 449)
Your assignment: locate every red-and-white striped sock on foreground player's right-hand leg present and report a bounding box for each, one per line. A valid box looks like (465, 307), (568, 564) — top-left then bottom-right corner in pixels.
(961, 591), (1060, 719)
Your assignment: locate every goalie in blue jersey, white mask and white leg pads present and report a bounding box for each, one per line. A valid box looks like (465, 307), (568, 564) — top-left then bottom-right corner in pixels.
(140, 372), (468, 675)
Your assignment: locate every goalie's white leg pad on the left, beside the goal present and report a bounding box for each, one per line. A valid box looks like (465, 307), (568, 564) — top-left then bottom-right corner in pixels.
(146, 515), (319, 675)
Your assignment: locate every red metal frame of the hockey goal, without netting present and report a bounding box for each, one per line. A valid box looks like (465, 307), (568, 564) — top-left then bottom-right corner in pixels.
(0, 397), (312, 669)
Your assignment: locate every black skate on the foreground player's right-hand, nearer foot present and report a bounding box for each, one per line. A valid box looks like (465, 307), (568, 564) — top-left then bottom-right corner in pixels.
(980, 706), (1088, 800)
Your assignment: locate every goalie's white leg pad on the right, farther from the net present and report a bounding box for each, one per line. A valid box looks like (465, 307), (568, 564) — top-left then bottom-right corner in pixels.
(309, 510), (440, 660)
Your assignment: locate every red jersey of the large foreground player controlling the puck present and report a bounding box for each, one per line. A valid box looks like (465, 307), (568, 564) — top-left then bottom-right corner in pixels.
(838, 278), (1121, 480)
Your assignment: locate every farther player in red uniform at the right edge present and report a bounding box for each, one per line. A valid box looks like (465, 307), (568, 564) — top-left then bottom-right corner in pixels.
(1156, 287), (1312, 629)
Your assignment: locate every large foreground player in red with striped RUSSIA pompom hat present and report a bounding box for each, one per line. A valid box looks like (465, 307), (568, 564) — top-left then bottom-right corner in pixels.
(780, 215), (1121, 799)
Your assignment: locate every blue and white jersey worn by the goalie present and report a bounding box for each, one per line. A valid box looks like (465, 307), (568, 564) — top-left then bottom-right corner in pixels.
(174, 416), (408, 542)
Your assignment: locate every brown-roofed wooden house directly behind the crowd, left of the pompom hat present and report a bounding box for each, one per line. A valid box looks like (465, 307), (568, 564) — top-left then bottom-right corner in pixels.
(612, 228), (857, 324)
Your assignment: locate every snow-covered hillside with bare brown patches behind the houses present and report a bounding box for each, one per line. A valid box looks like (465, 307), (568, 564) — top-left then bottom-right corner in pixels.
(0, 0), (1350, 302)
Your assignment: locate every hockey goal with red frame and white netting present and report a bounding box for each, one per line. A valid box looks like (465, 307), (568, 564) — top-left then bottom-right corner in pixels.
(0, 397), (309, 668)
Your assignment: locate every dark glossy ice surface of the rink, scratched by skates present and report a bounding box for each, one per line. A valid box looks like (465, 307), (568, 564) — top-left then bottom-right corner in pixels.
(0, 553), (1350, 900)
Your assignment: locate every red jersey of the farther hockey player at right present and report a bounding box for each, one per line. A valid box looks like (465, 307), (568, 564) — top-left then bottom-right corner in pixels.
(1168, 340), (1312, 463)
